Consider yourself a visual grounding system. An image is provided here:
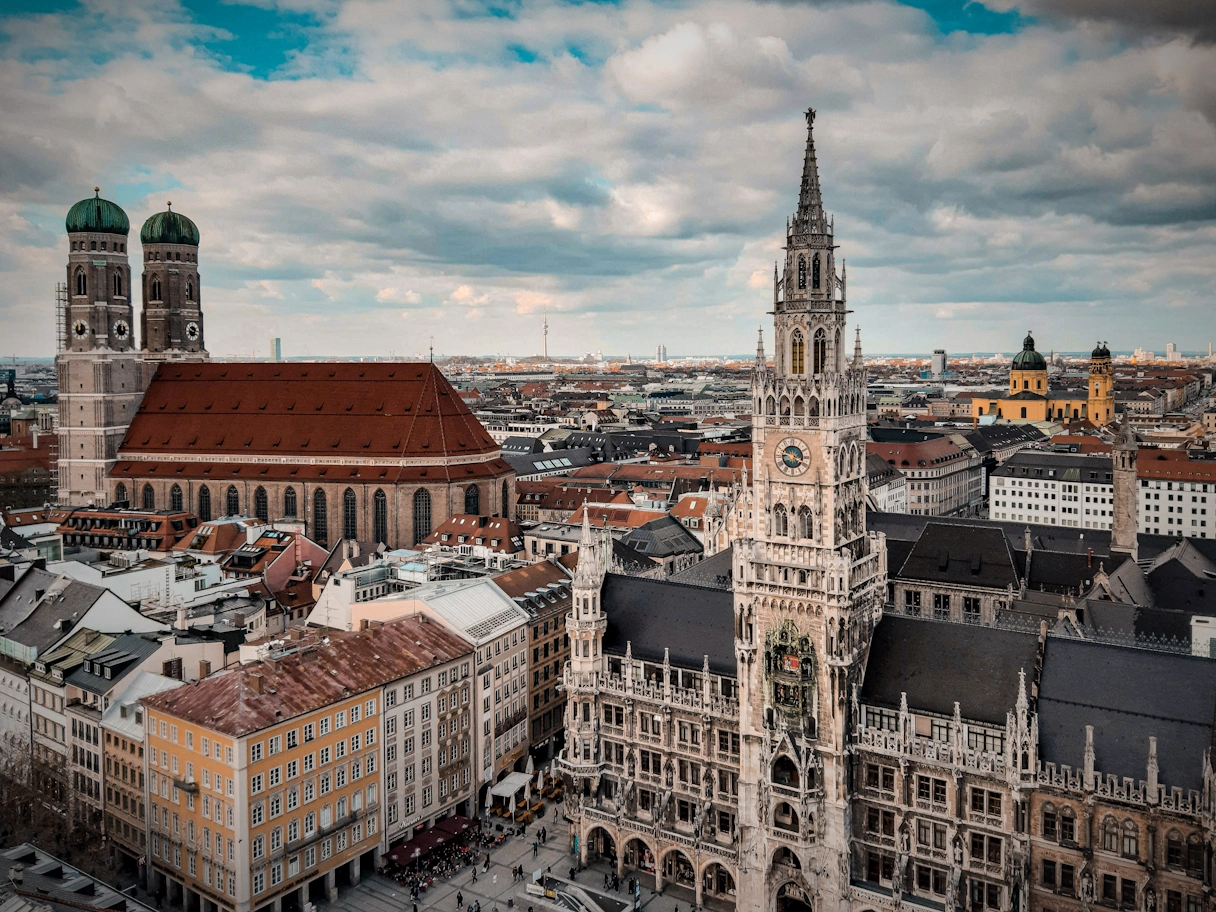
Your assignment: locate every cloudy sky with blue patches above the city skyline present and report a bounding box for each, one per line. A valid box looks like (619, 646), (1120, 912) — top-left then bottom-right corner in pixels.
(0, 0), (1216, 356)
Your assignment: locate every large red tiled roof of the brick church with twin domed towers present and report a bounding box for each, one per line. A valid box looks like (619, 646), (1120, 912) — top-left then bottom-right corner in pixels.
(113, 362), (511, 483)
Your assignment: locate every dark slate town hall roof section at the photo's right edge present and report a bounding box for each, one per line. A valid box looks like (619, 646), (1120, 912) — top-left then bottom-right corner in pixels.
(1038, 637), (1216, 789)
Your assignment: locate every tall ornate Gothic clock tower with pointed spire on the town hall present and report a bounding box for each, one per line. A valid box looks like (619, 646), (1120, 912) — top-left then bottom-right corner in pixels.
(731, 109), (886, 912)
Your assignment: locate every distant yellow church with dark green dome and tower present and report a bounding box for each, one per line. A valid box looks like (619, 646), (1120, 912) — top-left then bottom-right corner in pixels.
(972, 332), (1115, 426)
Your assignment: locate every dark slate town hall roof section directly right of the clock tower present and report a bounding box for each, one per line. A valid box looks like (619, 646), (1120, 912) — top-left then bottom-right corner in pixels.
(861, 614), (1040, 726)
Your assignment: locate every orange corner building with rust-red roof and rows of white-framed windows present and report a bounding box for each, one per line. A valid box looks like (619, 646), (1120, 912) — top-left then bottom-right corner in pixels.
(142, 615), (472, 912)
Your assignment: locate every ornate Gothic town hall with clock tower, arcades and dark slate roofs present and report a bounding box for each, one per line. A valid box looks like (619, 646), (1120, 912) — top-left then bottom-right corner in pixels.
(562, 111), (1216, 912)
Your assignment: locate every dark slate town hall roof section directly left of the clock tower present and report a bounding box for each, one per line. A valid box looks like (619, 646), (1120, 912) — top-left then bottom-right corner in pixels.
(601, 573), (736, 677)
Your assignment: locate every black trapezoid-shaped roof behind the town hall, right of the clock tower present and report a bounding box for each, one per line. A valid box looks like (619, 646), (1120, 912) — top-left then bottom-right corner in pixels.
(899, 522), (1018, 589)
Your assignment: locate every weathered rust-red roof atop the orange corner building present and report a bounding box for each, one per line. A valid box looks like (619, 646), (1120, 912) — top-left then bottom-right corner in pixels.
(143, 614), (472, 738)
